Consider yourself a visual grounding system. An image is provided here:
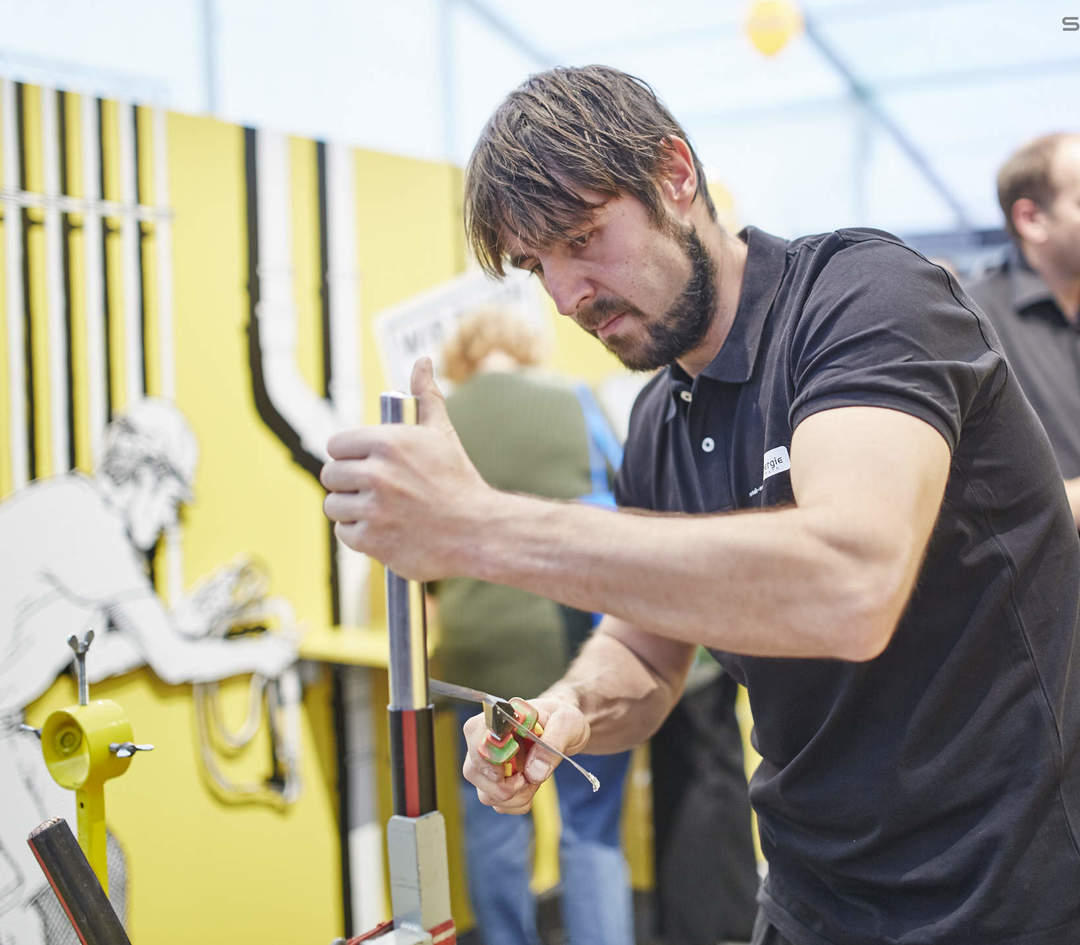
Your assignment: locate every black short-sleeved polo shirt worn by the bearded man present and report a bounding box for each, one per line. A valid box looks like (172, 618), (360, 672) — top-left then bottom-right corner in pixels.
(617, 228), (1080, 945)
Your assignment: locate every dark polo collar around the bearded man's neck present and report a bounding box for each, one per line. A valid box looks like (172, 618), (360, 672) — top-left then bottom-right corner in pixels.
(667, 227), (787, 419)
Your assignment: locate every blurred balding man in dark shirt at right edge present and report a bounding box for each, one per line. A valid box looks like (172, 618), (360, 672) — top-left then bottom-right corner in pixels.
(969, 133), (1080, 526)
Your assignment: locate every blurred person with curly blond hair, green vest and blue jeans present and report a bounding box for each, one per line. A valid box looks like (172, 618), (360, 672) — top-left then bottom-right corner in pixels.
(432, 310), (634, 945)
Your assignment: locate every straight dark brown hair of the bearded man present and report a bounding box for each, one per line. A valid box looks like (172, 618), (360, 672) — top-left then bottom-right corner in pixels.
(464, 66), (716, 275)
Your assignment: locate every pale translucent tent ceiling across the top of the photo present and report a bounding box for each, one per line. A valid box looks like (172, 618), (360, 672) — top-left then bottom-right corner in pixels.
(0, 0), (1080, 239)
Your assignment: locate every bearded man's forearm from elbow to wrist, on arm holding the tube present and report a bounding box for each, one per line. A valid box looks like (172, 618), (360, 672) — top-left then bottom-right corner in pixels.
(461, 494), (889, 657)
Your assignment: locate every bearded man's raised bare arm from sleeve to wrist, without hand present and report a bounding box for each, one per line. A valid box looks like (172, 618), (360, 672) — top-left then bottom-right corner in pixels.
(456, 407), (949, 660)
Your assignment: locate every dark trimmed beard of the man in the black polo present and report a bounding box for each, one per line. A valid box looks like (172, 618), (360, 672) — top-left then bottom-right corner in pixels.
(593, 221), (716, 370)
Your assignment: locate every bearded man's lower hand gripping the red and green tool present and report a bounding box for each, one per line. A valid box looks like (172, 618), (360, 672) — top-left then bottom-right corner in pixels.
(461, 696), (589, 813)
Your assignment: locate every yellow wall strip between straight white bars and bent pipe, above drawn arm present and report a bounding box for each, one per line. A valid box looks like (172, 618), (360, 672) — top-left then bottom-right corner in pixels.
(170, 116), (329, 639)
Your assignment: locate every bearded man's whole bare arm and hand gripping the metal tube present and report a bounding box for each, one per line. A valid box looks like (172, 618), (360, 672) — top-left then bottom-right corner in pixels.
(322, 380), (950, 660)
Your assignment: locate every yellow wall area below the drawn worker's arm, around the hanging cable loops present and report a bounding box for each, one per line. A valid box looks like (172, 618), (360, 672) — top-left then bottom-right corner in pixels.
(27, 669), (340, 945)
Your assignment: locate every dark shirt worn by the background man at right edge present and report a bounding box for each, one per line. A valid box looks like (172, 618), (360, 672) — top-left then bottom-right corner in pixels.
(968, 247), (1080, 480)
